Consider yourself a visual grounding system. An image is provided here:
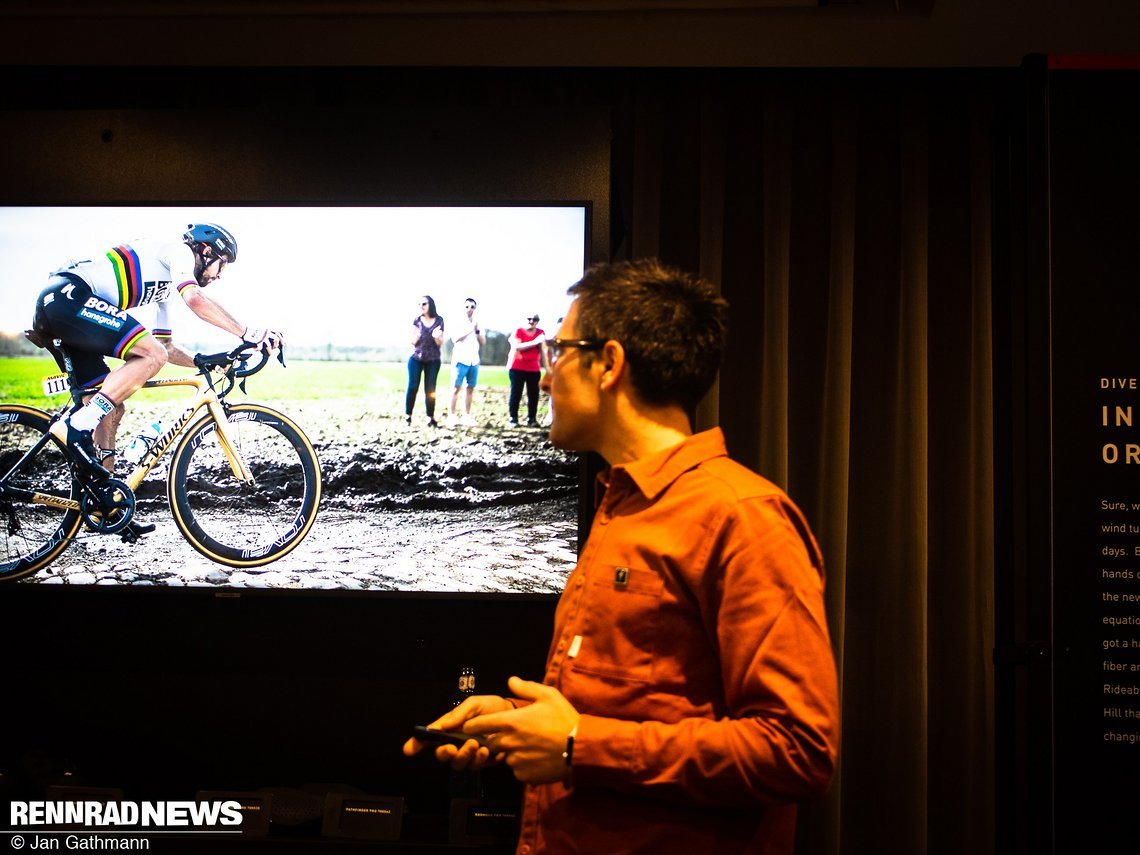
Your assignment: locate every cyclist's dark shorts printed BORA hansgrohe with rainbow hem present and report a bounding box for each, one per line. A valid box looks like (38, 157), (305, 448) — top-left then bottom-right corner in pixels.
(33, 274), (150, 389)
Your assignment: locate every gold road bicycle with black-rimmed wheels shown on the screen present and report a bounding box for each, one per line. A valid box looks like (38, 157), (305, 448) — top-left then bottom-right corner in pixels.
(0, 341), (321, 581)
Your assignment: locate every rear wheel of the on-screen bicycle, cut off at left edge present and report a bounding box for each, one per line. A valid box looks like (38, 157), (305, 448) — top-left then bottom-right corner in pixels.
(0, 404), (80, 581)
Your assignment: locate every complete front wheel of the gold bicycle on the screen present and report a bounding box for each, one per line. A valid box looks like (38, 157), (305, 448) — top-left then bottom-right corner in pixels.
(168, 404), (320, 567)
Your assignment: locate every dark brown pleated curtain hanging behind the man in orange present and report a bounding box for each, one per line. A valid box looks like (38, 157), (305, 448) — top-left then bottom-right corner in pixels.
(612, 70), (1003, 855)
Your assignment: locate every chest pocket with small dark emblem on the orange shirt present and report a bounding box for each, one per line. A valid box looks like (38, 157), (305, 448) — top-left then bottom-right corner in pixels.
(571, 565), (665, 682)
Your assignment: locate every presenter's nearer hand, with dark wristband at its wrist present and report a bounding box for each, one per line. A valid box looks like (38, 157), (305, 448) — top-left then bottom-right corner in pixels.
(465, 677), (580, 783)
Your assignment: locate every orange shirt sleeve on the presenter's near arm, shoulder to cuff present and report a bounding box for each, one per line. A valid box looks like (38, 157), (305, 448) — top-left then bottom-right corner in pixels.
(573, 497), (839, 806)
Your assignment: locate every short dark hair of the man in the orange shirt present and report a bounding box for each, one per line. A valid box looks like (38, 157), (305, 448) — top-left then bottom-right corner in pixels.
(569, 259), (728, 410)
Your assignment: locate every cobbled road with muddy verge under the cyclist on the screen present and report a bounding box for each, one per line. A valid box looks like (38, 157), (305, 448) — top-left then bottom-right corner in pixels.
(24, 404), (578, 593)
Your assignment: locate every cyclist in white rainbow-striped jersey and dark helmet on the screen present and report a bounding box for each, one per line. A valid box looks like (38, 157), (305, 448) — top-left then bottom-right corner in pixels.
(33, 222), (283, 515)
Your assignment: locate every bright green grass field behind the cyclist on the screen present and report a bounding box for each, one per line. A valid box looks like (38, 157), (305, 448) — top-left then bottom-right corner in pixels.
(0, 357), (510, 409)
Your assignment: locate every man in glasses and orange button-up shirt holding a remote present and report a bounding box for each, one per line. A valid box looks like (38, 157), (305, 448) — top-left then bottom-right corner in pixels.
(405, 261), (839, 855)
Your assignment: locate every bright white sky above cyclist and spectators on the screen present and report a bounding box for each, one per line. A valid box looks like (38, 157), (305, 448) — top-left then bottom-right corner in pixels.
(0, 206), (586, 347)
